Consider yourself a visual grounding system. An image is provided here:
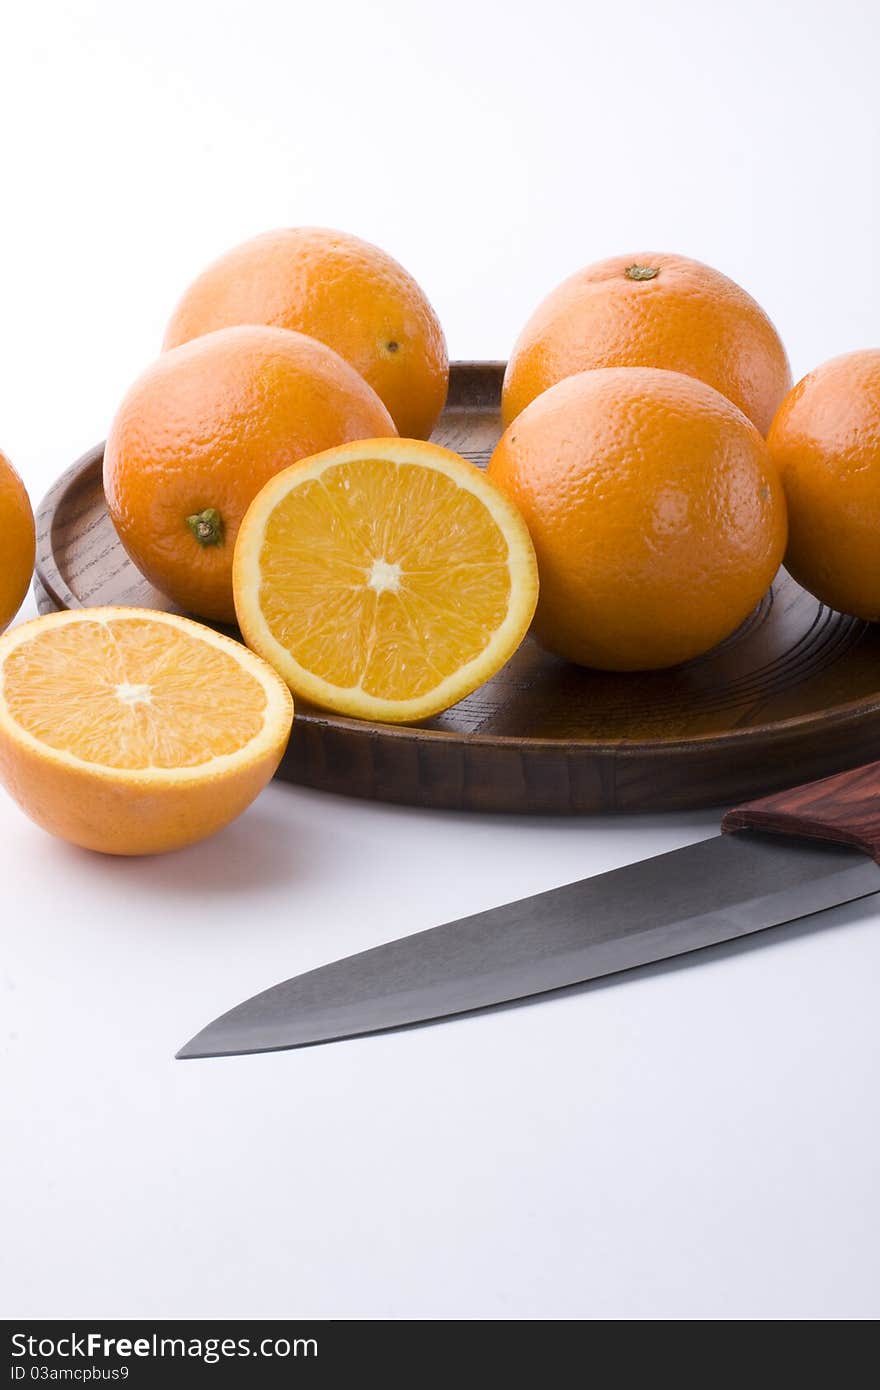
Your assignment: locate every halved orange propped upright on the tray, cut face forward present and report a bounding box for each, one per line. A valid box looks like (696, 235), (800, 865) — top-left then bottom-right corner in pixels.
(232, 439), (538, 723)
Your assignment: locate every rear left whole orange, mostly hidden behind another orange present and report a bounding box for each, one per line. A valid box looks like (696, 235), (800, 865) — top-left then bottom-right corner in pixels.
(164, 227), (449, 439)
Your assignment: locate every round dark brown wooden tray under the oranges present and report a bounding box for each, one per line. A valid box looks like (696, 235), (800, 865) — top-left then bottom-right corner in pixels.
(35, 363), (880, 813)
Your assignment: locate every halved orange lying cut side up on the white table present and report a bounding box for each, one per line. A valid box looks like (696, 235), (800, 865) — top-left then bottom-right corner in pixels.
(0, 607), (293, 855)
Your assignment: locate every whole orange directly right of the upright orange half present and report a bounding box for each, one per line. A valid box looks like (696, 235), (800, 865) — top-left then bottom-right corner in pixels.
(489, 367), (785, 671)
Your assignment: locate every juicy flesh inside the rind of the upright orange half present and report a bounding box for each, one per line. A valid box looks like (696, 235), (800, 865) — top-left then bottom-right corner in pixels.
(254, 459), (510, 701)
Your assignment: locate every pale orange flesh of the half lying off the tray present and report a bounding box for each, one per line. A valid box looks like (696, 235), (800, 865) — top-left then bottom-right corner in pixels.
(3, 619), (267, 770)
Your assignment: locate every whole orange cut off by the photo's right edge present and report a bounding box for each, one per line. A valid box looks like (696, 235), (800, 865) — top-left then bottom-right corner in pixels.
(767, 349), (880, 623)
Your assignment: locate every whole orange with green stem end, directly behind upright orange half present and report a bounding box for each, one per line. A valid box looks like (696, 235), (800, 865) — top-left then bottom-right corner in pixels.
(104, 327), (395, 623)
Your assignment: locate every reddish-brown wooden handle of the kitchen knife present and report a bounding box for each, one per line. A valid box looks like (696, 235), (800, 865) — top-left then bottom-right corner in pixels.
(722, 763), (880, 863)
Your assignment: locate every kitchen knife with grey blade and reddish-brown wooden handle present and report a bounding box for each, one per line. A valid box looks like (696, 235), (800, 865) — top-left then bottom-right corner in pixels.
(177, 762), (880, 1058)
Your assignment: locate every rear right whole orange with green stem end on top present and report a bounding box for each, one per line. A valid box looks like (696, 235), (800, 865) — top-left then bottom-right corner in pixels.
(503, 252), (791, 435)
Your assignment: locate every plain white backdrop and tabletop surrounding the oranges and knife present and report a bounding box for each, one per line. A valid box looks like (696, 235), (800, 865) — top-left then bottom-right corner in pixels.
(0, 0), (880, 1319)
